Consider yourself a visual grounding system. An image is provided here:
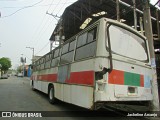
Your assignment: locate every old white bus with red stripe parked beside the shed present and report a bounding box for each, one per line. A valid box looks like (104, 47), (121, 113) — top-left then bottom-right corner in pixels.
(30, 18), (153, 110)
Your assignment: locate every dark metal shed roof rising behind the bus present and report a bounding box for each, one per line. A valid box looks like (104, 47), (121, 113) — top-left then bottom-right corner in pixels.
(50, 0), (160, 47)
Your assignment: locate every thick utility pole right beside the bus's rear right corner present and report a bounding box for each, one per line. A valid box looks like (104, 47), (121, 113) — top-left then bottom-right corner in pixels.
(143, 0), (160, 111)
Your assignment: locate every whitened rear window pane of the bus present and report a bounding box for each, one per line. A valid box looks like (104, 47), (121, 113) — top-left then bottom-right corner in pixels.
(108, 25), (148, 61)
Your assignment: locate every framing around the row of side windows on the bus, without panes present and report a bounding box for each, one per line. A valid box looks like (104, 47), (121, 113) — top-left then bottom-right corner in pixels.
(35, 22), (99, 71)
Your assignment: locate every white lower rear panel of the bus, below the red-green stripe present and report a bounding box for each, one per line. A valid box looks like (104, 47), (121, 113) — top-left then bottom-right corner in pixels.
(95, 84), (153, 102)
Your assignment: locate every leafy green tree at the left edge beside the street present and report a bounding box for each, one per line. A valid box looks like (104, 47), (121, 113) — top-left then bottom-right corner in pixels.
(0, 57), (12, 73)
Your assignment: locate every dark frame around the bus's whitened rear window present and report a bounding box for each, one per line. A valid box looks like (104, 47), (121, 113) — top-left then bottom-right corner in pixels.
(105, 21), (149, 63)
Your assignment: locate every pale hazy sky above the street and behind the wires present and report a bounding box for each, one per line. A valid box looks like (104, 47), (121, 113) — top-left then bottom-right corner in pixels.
(0, 0), (157, 69)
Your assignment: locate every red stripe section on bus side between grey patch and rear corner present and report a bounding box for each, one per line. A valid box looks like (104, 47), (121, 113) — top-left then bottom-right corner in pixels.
(66, 71), (94, 86)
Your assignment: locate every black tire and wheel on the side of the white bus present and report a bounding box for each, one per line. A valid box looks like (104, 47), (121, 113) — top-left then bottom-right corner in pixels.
(48, 86), (56, 104)
